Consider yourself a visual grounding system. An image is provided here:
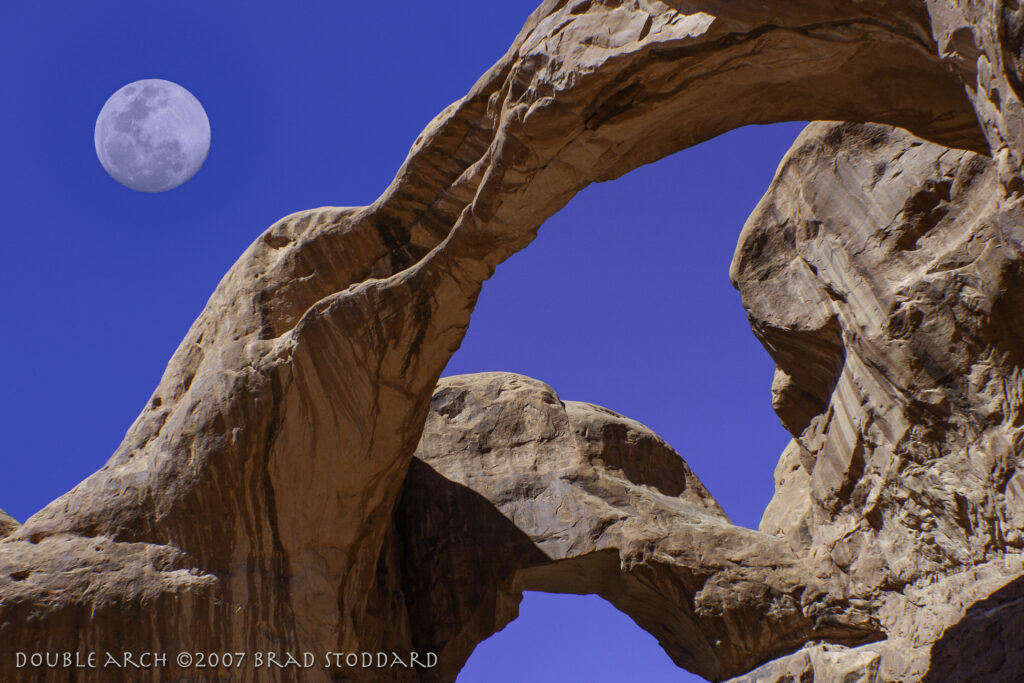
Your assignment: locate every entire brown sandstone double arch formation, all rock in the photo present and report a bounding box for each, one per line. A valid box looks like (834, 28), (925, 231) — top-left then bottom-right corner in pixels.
(0, 0), (1024, 681)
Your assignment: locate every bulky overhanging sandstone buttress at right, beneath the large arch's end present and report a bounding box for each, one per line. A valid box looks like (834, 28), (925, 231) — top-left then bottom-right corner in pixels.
(732, 124), (1024, 680)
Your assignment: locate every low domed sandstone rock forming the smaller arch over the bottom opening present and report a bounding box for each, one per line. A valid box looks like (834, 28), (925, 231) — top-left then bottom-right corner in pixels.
(396, 373), (881, 680)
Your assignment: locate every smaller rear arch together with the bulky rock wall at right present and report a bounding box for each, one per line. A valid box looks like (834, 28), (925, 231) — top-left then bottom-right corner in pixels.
(395, 117), (1024, 683)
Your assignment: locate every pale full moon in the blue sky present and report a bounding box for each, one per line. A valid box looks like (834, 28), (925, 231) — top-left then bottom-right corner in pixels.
(95, 78), (210, 193)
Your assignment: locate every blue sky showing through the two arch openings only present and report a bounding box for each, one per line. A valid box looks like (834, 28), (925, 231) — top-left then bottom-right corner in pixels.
(436, 123), (805, 683)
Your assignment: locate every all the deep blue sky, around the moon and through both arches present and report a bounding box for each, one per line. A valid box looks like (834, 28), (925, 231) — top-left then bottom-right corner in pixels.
(0, 0), (800, 683)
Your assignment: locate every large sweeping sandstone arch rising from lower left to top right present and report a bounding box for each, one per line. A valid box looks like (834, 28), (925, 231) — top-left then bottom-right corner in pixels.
(0, 1), (1014, 680)
